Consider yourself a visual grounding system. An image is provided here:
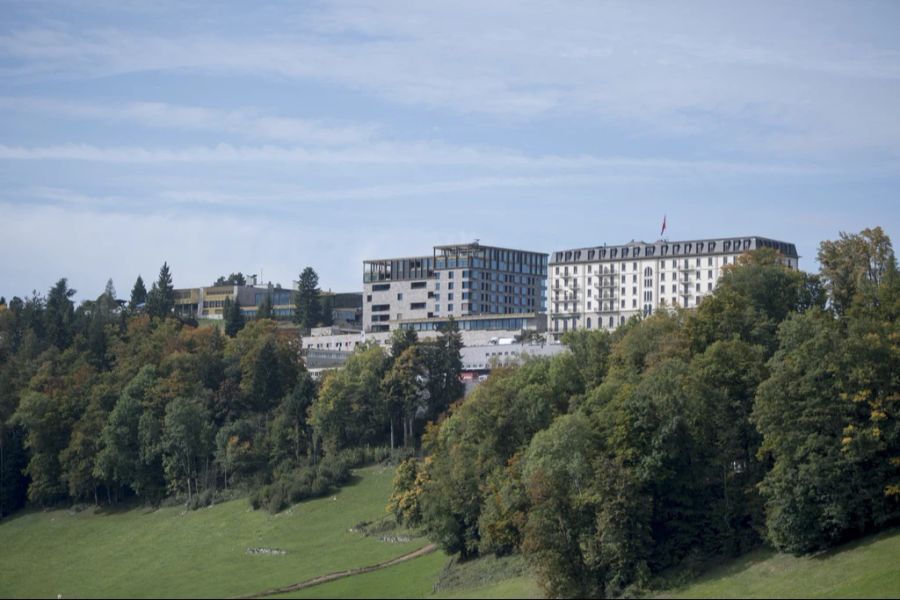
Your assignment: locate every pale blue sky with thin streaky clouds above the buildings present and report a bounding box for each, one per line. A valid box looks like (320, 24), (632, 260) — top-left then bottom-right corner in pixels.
(0, 0), (900, 299)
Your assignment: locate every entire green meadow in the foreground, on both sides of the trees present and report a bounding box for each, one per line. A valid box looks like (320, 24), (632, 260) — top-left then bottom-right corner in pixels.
(0, 467), (900, 598)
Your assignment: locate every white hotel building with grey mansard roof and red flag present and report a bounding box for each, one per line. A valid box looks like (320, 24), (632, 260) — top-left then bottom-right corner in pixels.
(547, 236), (799, 339)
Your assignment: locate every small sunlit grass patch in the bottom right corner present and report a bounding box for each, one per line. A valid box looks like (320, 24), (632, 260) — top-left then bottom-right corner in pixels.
(661, 529), (900, 598)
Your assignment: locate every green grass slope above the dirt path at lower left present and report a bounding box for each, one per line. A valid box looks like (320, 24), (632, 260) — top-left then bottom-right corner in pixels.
(0, 467), (427, 598)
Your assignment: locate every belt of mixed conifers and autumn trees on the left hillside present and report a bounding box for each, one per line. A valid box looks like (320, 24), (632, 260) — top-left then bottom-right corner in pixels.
(0, 264), (462, 517)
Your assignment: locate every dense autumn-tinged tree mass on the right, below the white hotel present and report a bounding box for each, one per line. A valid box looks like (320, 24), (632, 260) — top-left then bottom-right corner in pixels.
(390, 228), (900, 597)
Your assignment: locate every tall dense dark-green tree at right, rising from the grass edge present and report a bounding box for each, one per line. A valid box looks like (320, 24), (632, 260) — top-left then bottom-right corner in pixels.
(753, 311), (880, 553)
